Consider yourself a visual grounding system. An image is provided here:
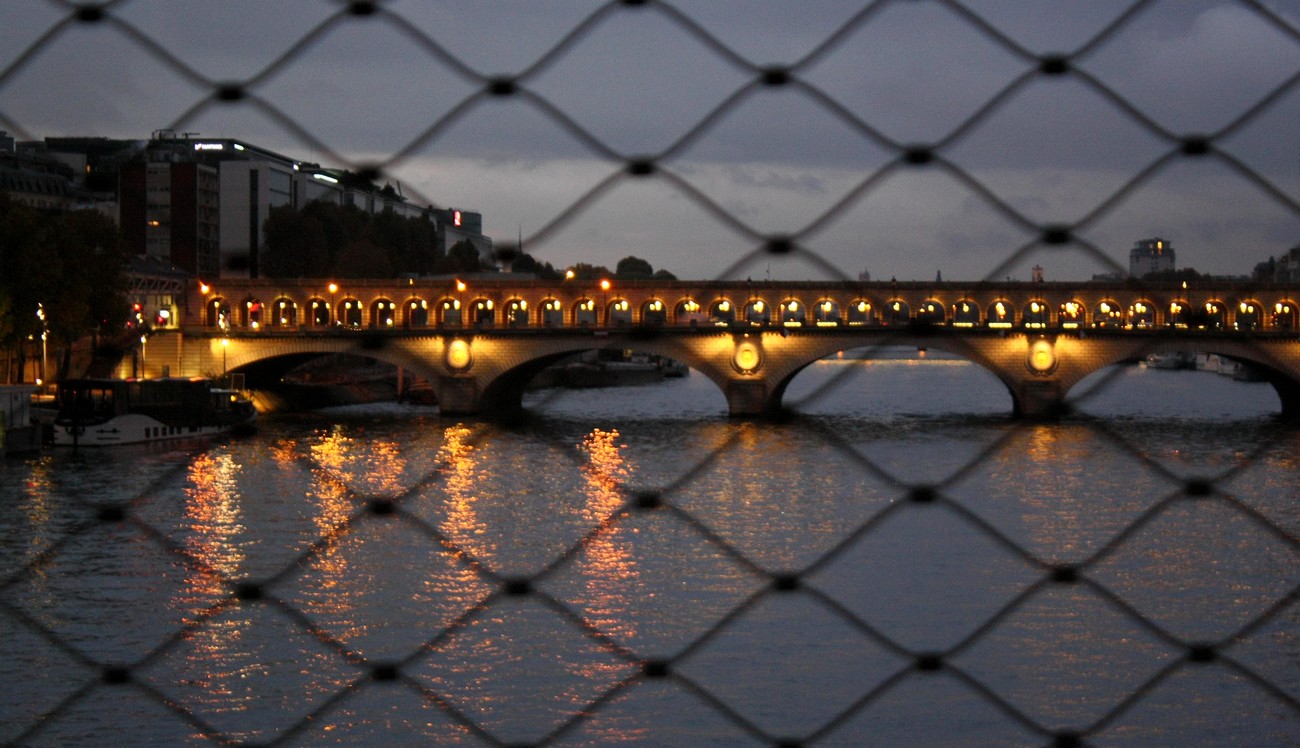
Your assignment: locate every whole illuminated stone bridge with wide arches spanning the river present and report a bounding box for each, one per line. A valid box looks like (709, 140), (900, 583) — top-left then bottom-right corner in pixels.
(137, 278), (1300, 419)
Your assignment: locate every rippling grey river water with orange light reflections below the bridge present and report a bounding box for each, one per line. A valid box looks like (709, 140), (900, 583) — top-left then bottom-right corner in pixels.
(0, 356), (1300, 745)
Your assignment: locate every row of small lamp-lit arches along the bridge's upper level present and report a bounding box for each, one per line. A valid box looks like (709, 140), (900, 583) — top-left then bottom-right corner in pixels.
(204, 297), (1297, 330)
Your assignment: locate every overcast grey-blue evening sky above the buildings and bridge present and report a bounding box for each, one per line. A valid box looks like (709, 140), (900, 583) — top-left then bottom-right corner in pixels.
(0, 0), (1300, 280)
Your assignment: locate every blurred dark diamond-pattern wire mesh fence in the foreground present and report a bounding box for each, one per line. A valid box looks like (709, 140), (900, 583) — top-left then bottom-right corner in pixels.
(0, 0), (1300, 747)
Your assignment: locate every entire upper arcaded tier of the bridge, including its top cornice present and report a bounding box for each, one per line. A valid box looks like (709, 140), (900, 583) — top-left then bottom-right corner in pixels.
(185, 280), (1300, 333)
